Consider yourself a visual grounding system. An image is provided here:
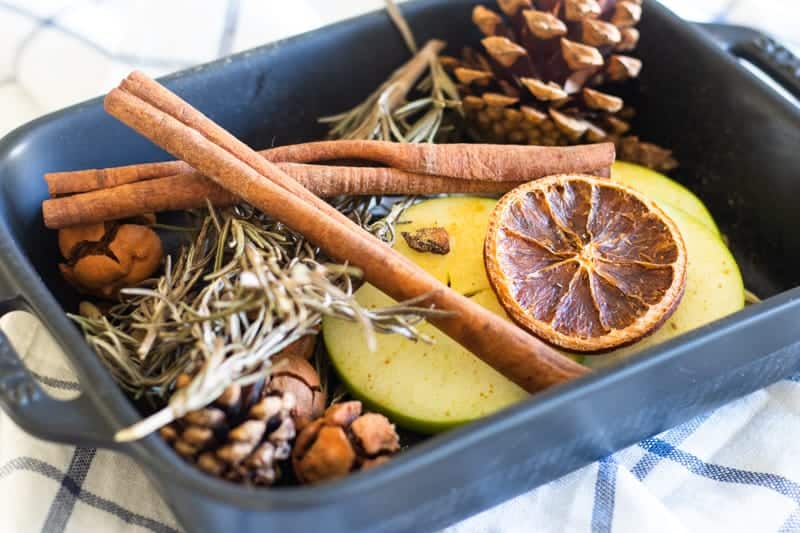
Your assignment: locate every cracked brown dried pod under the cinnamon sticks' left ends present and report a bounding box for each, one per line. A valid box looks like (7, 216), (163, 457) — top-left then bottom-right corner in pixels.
(58, 217), (163, 299)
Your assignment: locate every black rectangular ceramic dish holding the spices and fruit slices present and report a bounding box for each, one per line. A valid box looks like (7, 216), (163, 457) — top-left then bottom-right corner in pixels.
(0, 0), (800, 532)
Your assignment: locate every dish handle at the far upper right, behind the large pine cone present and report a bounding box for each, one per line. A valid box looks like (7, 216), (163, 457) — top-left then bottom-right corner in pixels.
(701, 24), (800, 99)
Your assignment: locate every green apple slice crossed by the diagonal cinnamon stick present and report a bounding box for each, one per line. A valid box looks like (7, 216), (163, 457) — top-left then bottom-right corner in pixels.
(322, 197), (527, 433)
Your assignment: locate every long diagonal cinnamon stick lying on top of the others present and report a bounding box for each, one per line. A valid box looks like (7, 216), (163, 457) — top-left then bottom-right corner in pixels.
(105, 72), (588, 392)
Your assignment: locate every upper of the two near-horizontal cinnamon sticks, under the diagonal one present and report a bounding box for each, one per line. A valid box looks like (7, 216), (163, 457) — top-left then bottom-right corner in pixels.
(45, 141), (614, 196)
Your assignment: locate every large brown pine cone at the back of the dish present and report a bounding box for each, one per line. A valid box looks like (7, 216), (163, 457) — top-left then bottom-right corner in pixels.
(444, 0), (664, 164)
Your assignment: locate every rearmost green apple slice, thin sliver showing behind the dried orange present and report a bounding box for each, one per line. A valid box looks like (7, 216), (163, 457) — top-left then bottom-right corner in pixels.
(611, 161), (719, 234)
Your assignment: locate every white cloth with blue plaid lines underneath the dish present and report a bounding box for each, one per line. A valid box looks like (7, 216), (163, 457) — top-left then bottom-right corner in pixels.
(0, 0), (800, 533)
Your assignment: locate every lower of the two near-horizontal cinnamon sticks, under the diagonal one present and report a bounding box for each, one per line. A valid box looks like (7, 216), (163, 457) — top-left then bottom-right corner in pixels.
(42, 163), (519, 229)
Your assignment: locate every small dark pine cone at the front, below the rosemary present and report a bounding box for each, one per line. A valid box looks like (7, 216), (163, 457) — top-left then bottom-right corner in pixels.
(160, 375), (295, 485)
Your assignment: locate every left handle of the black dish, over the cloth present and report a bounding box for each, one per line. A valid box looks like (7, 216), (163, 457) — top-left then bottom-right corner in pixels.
(0, 293), (115, 448)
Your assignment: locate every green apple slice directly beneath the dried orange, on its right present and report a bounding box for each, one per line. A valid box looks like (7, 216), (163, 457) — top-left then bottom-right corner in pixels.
(583, 205), (744, 368)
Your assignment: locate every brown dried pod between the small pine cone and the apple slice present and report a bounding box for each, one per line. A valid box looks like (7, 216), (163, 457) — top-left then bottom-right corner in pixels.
(267, 355), (326, 431)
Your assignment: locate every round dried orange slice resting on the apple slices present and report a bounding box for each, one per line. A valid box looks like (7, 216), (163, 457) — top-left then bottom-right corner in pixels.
(484, 175), (687, 352)
